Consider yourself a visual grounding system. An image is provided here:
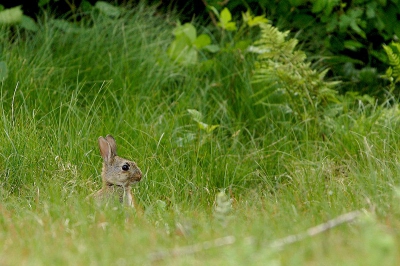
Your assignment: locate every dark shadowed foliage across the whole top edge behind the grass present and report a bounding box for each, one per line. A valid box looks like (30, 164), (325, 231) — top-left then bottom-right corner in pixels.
(0, 0), (400, 96)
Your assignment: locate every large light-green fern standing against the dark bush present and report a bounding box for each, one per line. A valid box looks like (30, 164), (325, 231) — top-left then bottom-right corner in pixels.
(253, 24), (337, 121)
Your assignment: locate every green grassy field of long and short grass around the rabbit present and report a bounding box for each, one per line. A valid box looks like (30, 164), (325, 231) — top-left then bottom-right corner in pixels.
(0, 5), (400, 265)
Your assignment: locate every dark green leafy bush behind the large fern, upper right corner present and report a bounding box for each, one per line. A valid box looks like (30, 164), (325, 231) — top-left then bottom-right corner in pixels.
(208, 0), (400, 96)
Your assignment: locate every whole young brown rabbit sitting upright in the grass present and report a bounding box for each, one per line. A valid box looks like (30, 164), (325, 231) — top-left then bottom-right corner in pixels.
(93, 135), (142, 207)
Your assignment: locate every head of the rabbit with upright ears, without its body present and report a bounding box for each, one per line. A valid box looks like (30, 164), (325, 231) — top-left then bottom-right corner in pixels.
(98, 135), (142, 188)
